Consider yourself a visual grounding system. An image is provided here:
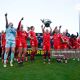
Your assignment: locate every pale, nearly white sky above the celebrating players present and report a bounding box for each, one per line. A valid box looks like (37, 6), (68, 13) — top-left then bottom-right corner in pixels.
(0, 0), (80, 33)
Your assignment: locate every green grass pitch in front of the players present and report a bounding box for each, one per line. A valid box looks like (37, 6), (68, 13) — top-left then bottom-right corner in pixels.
(0, 56), (80, 80)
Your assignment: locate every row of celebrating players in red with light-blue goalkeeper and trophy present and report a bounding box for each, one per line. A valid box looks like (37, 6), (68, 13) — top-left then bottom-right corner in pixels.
(1, 13), (80, 67)
